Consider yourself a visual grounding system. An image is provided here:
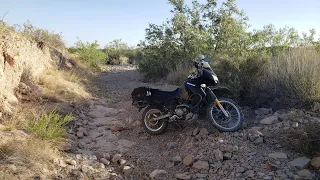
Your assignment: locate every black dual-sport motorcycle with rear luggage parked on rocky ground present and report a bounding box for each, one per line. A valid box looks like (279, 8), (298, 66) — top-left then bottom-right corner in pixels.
(131, 57), (243, 135)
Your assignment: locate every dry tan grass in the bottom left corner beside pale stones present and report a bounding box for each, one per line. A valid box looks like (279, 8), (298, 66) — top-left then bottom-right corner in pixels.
(0, 137), (59, 179)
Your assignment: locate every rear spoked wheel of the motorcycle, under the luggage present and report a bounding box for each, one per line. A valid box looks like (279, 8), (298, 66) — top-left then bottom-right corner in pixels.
(142, 107), (168, 135)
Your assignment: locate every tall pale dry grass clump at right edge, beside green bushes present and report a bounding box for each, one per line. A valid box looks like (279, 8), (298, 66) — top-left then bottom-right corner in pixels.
(258, 47), (320, 102)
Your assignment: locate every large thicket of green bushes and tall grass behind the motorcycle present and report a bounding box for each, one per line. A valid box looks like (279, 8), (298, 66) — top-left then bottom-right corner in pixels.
(137, 0), (320, 107)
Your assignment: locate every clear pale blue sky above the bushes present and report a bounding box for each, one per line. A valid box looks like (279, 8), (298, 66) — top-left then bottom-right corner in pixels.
(0, 0), (320, 47)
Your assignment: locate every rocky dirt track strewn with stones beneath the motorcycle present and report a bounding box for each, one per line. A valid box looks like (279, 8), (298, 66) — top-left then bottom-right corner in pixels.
(56, 66), (320, 180)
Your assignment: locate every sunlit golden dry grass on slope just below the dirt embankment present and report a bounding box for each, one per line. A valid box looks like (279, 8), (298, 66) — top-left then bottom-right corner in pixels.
(39, 69), (91, 101)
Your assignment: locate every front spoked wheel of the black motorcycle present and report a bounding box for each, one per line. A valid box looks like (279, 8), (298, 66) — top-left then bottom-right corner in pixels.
(208, 98), (243, 132)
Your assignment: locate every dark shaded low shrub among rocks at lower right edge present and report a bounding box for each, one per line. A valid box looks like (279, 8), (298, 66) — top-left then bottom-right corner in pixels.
(280, 122), (320, 157)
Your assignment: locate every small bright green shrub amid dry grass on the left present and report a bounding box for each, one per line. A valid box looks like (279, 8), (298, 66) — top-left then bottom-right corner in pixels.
(25, 110), (72, 141)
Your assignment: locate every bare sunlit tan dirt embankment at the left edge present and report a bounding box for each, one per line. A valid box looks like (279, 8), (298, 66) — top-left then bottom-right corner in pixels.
(0, 32), (51, 112)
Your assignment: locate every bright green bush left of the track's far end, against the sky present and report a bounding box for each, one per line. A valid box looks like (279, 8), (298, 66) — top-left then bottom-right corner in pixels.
(69, 40), (107, 67)
